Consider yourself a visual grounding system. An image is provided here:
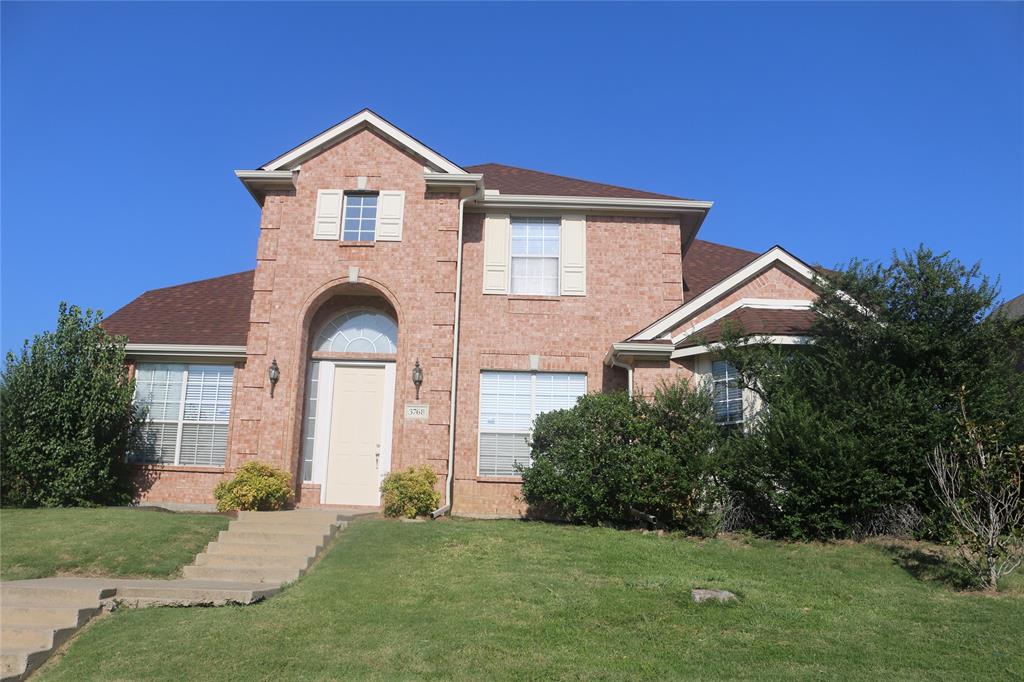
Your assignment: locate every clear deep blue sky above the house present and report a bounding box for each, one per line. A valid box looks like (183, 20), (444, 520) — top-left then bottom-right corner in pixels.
(0, 2), (1024, 356)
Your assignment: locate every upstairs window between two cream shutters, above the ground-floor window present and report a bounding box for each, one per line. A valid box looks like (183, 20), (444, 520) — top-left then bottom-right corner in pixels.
(509, 216), (561, 296)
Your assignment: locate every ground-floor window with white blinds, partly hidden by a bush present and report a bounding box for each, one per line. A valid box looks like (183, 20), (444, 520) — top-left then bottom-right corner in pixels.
(477, 372), (587, 476)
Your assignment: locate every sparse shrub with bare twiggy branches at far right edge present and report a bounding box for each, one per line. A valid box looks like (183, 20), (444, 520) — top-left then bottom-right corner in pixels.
(928, 395), (1024, 590)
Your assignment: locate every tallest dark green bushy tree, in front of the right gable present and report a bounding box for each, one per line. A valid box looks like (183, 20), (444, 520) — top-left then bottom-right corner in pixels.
(723, 248), (1024, 539)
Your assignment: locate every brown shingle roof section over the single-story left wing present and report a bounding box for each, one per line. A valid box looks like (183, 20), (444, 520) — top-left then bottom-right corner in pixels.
(103, 270), (253, 346)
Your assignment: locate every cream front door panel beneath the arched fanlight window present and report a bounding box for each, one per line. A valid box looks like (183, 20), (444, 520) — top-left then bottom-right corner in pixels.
(324, 365), (390, 506)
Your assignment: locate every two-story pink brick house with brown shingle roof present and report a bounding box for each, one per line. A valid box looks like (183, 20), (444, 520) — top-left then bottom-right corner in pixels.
(104, 110), (814, 516)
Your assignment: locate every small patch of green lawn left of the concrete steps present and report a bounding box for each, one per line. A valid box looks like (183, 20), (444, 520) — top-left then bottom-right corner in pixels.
(0, 508), (230, 580)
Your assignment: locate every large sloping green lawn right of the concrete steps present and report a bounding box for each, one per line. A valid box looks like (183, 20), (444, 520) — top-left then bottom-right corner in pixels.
(32, 520), (1024, 681)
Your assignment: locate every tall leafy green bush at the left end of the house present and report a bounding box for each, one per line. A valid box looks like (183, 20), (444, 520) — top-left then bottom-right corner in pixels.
(0, 303), (138, 507)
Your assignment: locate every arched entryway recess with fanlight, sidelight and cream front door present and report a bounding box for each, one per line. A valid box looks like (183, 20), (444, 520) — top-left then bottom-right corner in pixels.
(301, 296), (398, 506)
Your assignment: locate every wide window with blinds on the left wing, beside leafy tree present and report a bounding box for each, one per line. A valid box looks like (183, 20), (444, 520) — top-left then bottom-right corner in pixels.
(128, 363), (234, 467)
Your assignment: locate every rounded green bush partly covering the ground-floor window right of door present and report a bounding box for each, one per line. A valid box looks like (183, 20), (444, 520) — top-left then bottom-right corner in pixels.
(522, 382), (727, 534)
